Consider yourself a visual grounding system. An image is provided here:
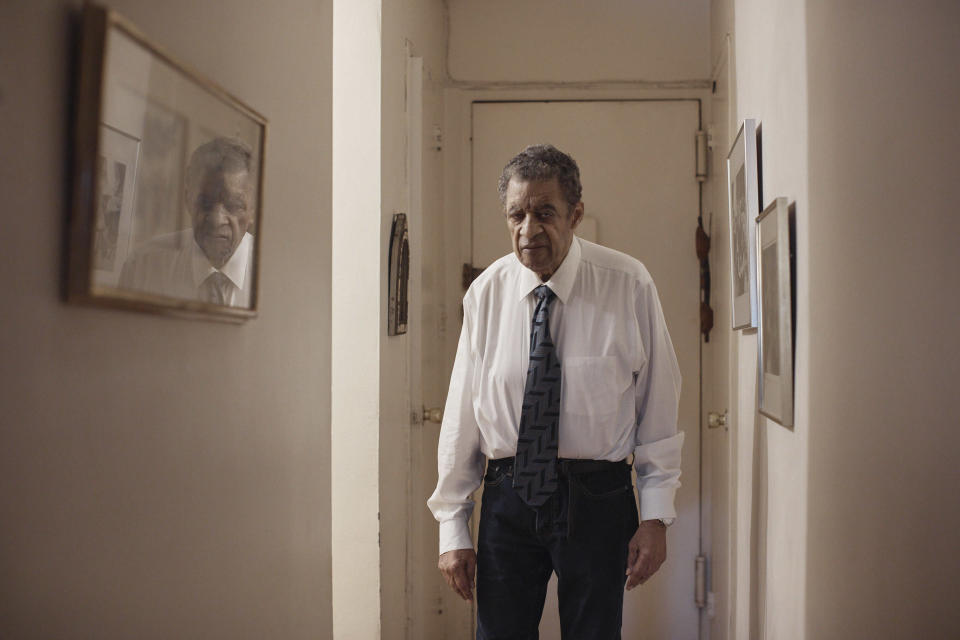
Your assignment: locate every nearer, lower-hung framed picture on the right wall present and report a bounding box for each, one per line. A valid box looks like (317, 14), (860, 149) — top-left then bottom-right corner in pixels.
(757, 198), (794, 427)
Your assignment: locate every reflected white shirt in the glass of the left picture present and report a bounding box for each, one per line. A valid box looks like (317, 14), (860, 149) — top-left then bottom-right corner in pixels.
(120, 229), (253, 308)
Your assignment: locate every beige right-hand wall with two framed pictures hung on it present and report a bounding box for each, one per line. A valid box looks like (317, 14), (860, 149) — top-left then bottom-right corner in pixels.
(711, 0), (960, 638)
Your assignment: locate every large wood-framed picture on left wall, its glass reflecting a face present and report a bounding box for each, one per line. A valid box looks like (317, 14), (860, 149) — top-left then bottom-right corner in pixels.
(66, 3), (267, 320)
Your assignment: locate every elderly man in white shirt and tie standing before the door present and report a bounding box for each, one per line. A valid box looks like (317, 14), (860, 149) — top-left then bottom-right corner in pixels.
(428, 145), (683, 640)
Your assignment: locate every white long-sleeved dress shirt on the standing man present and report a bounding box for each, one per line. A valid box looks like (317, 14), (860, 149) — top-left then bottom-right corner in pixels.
(427, 237), (683, 553)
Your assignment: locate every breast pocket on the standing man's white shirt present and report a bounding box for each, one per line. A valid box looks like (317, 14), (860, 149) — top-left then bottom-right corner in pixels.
(561, 356), (633, 419)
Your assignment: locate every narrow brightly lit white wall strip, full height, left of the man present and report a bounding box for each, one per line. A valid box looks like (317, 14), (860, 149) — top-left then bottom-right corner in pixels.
(331, 0), (386, 640)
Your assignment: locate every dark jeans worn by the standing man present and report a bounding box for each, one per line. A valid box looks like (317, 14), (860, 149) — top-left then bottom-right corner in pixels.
(477, 458), (639, 640)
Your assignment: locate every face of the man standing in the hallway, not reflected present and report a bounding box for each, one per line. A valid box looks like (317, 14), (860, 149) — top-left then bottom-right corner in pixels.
(504, 178), (583, 282)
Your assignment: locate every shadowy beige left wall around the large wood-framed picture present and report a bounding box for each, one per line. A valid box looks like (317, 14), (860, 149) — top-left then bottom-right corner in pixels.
(0, 0), (331, 638)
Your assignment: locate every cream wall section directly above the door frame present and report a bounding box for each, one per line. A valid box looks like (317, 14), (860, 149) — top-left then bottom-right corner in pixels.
(447, 0), (710, 83)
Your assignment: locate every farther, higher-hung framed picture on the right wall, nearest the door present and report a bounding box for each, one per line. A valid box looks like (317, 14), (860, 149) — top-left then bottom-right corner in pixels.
(727, 120), (760, 329)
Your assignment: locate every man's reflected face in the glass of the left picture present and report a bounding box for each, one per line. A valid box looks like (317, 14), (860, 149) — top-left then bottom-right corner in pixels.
(187, 169), (254, 269)
